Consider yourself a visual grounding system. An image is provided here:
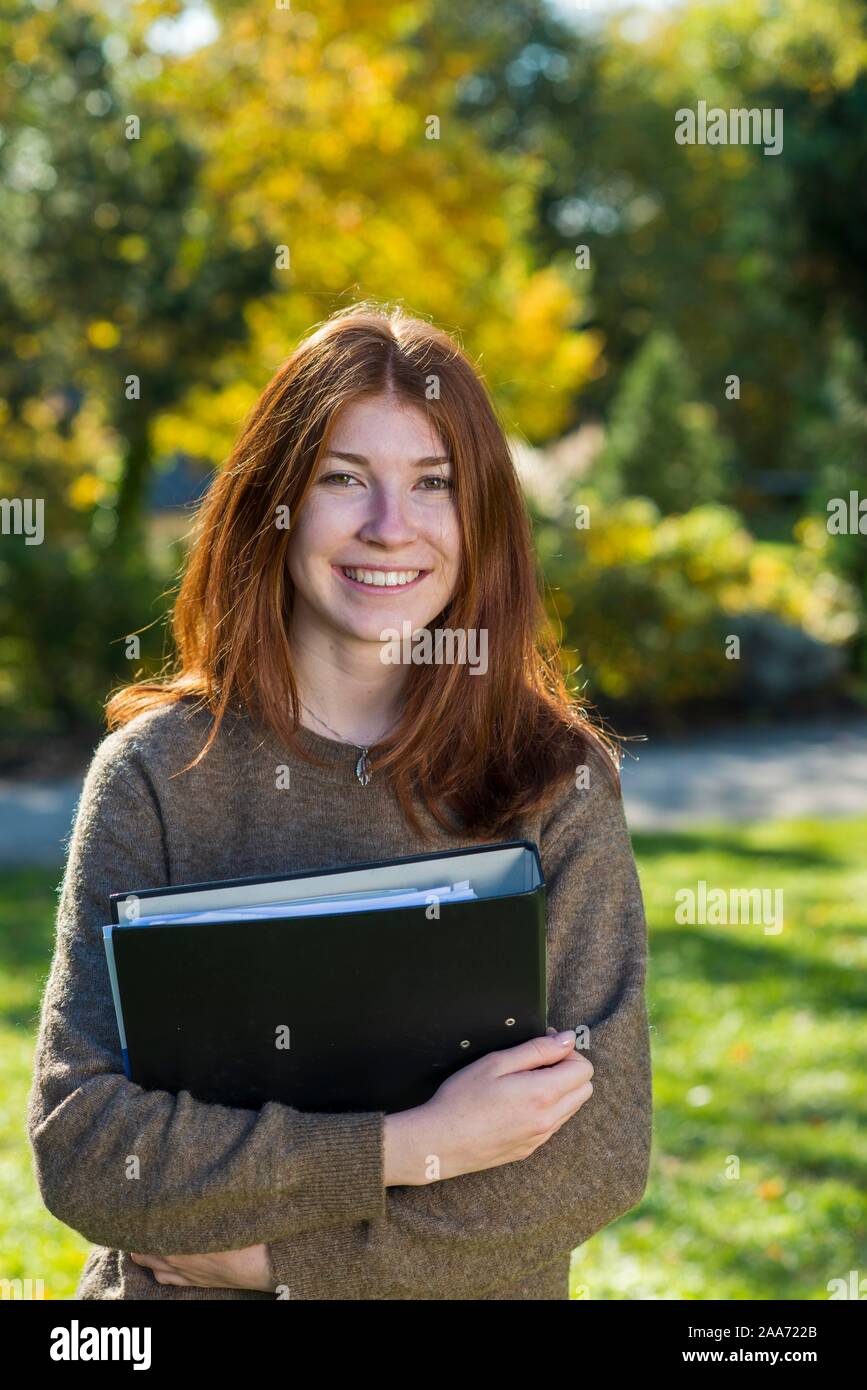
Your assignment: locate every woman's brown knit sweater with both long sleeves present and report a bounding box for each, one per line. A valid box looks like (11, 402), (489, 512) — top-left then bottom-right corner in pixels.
(28, 703), (652, 1300)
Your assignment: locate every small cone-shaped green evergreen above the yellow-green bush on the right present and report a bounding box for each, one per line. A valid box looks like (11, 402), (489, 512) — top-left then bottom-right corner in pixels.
(591, 329), (728, 512)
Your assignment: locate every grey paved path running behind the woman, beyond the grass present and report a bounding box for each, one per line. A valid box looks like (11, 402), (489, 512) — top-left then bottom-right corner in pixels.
(0, 720), (867, 865)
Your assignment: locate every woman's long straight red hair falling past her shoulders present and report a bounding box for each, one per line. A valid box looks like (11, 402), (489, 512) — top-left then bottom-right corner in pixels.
(107, 303), (618, 835)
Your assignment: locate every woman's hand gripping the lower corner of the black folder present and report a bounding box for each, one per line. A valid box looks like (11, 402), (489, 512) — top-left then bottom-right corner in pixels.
(385, 1029), (593, 1186)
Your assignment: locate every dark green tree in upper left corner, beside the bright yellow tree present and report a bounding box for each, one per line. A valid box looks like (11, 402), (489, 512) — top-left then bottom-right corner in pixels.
(0, 3), (272, 563)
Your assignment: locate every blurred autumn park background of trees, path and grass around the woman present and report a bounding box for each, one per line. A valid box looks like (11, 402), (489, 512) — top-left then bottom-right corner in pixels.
(0, 0), (867, 1298)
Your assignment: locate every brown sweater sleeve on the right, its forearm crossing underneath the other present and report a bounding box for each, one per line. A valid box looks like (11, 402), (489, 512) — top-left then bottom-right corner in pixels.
(270, 755), (652, 1300)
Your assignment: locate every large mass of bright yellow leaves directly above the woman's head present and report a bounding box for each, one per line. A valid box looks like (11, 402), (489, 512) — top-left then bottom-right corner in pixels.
(128, 0), (604, 447)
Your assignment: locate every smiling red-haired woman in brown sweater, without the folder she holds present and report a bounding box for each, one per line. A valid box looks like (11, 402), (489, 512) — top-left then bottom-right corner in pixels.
(29, 304), (650, 1300)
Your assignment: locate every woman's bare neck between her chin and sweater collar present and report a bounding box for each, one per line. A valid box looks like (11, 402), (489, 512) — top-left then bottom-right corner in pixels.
(290, 626), (406, 748)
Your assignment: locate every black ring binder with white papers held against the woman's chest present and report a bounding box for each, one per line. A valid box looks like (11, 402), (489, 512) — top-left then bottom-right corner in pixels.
(104, 840), (547, 1113)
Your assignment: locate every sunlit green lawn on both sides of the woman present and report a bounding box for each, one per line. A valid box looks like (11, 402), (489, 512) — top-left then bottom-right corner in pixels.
(0, 817), (867, 1300)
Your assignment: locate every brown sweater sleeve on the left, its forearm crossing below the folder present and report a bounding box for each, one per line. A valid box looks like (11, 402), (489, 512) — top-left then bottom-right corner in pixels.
(26, 731), (385, 1255)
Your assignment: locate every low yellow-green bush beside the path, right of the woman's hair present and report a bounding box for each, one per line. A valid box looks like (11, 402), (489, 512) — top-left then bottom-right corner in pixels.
(538, 491), (857, 719)
